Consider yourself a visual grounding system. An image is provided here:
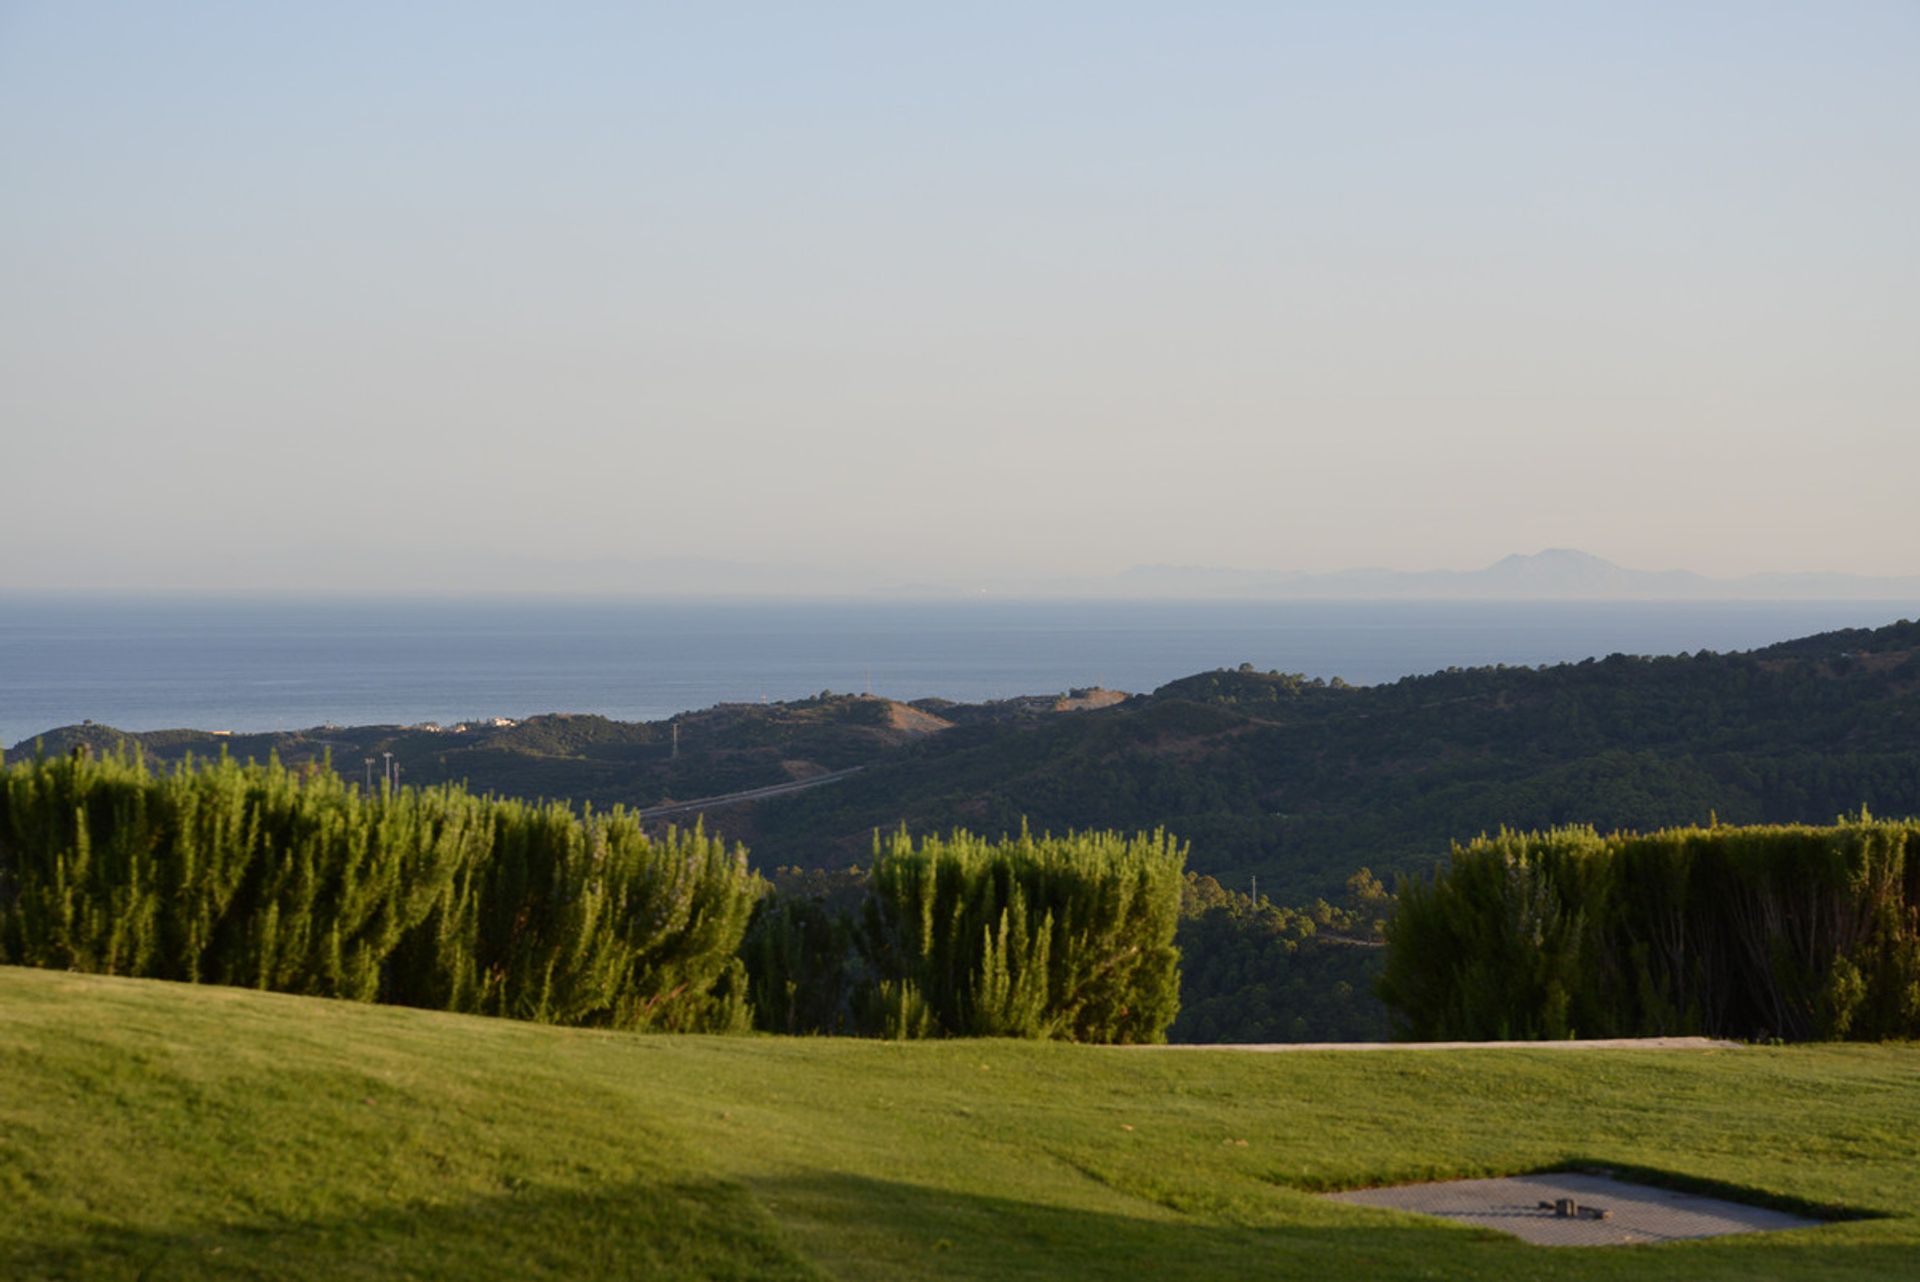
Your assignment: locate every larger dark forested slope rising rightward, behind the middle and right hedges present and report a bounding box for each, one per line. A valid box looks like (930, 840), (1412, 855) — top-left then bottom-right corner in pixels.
(753, 622), (1920, 902)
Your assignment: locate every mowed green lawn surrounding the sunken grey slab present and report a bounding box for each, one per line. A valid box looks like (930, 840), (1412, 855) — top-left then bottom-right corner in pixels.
(0, 969), (1920, 1282)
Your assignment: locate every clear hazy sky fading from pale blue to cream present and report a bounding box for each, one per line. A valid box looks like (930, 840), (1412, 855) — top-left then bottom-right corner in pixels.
(0, 0), (1920, 587)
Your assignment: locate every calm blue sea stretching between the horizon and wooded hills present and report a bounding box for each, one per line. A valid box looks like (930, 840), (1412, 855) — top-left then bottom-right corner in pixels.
(0, 597), (1920, 745)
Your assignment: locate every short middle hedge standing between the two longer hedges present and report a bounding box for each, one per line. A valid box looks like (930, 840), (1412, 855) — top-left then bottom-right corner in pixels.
(745, 831), (1187, 1042)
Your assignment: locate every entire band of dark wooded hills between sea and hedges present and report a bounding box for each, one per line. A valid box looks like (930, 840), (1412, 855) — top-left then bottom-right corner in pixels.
(15, 622), (1920, 904)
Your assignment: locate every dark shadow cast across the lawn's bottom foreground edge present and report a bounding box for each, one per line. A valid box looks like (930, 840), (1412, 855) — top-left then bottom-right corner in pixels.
(0, 1173), (1916, 1282)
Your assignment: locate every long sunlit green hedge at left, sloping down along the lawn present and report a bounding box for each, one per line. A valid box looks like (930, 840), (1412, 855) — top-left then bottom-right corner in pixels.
(0, 754), (764, 1029)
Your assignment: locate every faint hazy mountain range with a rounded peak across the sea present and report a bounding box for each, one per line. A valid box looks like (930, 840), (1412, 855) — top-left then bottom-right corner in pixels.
(1023, 547), (1920, 601)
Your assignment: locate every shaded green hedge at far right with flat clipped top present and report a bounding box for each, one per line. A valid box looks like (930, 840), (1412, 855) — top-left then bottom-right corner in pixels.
(1380, 814), (1920, 1040)
